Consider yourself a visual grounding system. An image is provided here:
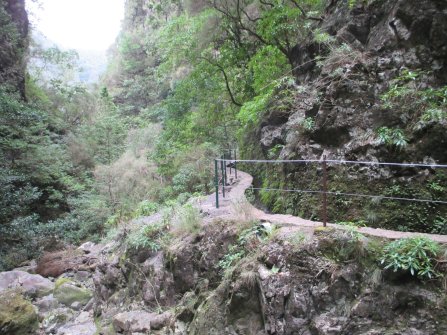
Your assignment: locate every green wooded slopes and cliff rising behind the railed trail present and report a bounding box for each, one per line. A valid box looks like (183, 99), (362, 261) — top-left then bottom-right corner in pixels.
(0, 0), (447, 268)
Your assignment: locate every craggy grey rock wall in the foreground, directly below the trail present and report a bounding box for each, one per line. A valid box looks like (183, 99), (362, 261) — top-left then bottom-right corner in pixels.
(89, 221), (447, 335)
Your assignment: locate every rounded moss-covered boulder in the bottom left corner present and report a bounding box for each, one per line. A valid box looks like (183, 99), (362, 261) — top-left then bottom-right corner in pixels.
(0, 291), (39, 335)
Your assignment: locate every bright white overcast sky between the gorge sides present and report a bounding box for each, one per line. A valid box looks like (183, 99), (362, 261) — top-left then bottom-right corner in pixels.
(26, 0), (125, 50)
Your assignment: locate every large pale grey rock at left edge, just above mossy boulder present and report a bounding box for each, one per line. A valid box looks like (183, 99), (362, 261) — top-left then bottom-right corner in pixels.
(0, 270), (54, 297)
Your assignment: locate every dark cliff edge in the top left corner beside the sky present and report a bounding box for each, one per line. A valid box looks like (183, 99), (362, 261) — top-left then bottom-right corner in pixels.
(0, 0), (29, 97)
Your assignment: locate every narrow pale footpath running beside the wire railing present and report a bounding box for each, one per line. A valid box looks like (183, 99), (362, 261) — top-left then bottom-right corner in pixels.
(197, 170), (447, 243)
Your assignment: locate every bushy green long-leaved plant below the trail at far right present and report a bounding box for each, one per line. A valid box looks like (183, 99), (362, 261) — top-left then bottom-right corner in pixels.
(381, 237), (441, 278)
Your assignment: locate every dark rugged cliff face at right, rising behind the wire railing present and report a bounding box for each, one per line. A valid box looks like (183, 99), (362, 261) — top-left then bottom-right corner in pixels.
(247, 0), (447, 231)
